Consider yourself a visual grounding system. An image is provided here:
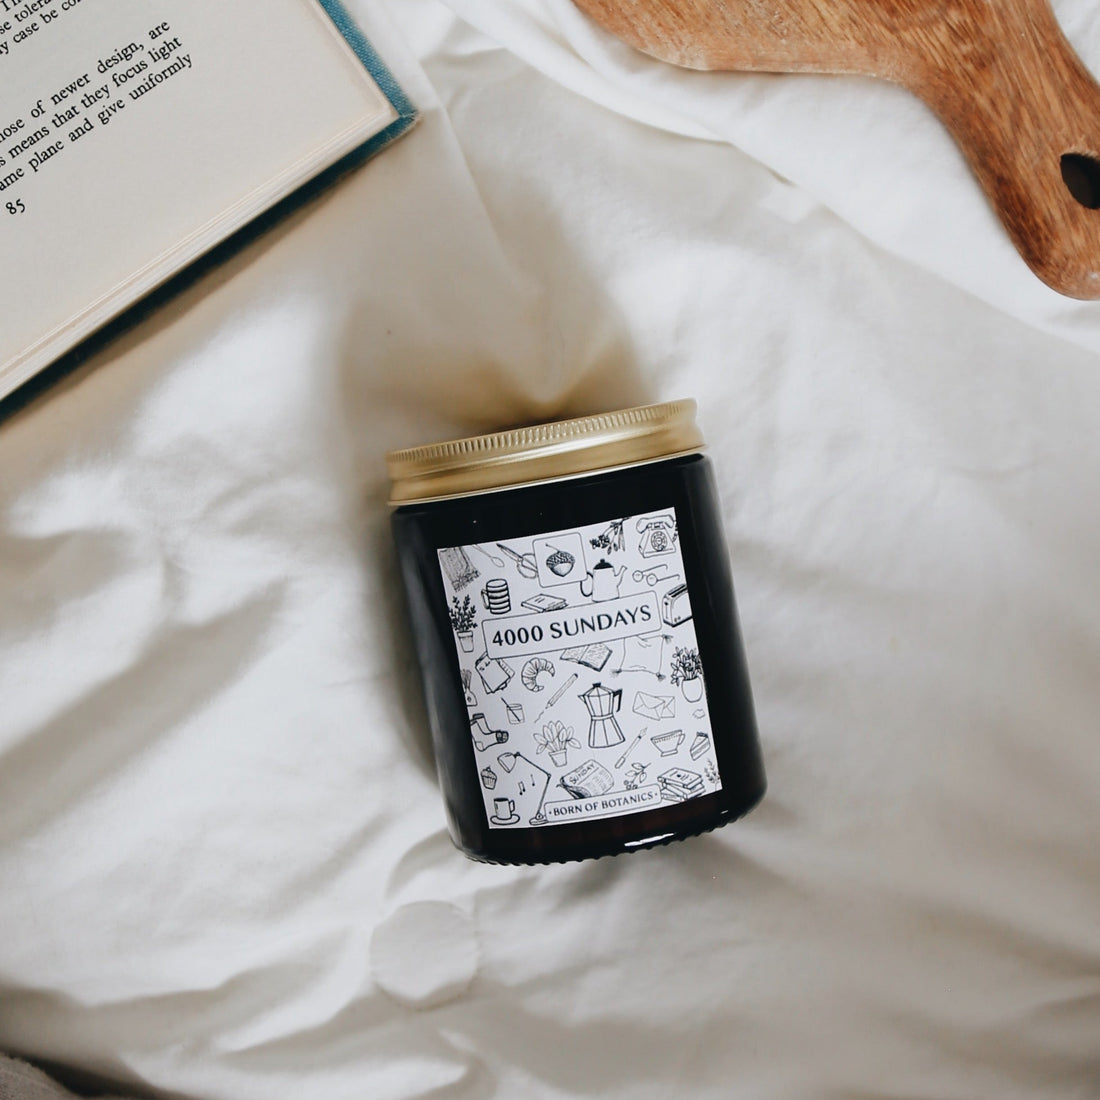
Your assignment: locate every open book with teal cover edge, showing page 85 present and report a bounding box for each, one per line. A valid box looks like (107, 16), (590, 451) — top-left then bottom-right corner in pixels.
(0, 0), (415, 397)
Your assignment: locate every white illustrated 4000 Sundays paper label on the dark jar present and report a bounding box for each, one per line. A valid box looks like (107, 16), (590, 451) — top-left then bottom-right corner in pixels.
(439, 512), (722, 828)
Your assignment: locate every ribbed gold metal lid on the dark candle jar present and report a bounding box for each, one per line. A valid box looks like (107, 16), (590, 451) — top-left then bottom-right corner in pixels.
(386, 399), (704, 505)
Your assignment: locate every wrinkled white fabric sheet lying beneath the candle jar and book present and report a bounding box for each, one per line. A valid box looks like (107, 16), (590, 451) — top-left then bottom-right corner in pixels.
(0, 0), (1100, 1100)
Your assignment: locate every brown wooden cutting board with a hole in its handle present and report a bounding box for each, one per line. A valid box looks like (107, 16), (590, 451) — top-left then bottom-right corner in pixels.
(574, 0), (1100, 298)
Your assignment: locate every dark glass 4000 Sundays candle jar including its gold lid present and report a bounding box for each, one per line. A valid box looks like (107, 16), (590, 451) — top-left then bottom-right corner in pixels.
(387, 400), (765, 864)
